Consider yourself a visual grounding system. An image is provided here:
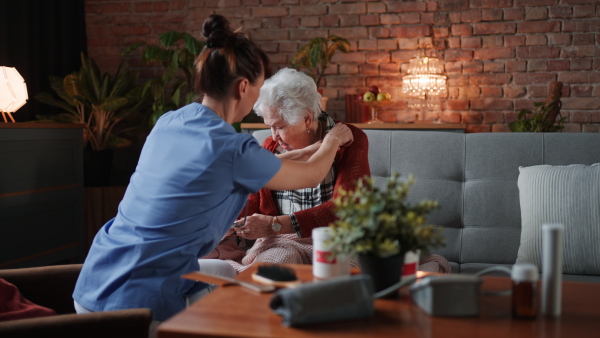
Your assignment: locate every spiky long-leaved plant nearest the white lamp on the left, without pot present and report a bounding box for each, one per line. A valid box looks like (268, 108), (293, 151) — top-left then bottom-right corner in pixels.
(35, 53), (141, 150)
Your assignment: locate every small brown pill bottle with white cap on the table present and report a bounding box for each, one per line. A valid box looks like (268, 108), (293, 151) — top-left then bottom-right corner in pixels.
(511, 263), (539, 319)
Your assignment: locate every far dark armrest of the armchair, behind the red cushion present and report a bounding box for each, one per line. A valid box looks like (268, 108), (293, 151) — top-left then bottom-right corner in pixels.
(0, 264), (82, 314)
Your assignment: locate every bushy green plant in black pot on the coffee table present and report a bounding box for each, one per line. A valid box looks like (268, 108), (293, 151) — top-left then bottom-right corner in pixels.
(329, 172), (444, 291)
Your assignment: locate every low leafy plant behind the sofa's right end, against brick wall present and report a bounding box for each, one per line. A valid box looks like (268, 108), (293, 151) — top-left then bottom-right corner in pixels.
(508, 97), (566, 132)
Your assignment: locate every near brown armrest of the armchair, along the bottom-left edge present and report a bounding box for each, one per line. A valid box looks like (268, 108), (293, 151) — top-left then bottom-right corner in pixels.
(0, 309), (152, 338)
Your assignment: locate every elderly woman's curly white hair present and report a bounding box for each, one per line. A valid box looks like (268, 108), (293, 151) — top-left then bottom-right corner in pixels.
(254, 68), (321, 125)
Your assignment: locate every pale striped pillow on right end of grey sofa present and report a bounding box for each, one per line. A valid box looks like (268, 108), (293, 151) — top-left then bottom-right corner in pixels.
(517, 163), (600, 275)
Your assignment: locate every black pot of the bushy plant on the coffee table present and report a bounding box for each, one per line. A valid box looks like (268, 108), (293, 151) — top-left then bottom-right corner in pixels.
(358, 253), (404, 298)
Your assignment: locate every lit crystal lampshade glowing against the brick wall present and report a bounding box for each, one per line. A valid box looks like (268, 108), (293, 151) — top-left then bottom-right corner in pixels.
(402, 51), (447, 119)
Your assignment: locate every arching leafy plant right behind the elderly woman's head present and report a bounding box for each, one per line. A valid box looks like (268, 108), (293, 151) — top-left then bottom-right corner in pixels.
(292, 35), (350, 110)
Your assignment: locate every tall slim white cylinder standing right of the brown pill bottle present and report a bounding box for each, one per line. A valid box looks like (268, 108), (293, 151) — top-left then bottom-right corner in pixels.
(542, 224), (565, 317)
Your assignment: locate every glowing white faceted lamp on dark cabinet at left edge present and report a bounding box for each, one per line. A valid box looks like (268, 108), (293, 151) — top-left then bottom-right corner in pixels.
(0, 66), (28, 122)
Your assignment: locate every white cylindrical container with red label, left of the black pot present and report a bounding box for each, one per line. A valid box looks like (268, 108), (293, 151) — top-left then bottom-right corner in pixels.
(312, 227), (350, 279)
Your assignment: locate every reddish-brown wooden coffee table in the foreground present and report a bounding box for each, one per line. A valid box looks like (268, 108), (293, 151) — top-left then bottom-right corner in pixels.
(158, 265), (600, 338)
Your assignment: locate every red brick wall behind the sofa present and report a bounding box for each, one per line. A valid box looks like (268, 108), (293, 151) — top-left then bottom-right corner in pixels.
(86, 0), (600, 132)
